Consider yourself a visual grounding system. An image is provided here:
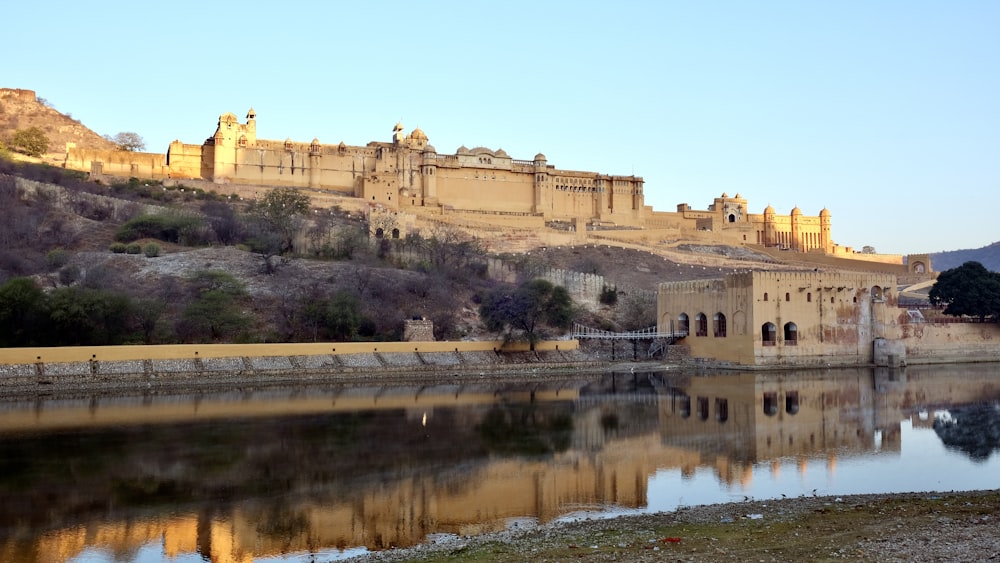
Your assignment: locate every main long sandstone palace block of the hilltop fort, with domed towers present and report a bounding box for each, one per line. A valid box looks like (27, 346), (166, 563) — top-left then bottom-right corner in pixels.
(154, 109), (645, 223)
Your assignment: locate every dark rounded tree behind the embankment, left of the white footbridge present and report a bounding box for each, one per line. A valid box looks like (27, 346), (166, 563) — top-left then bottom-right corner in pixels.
(479, 279), (573, 348)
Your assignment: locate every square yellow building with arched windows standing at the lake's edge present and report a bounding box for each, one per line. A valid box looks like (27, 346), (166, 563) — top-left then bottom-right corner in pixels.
(657, 271), (900, 366)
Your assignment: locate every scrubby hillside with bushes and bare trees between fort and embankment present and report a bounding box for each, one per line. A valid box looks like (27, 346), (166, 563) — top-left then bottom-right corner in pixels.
(0, 156), (632, 346)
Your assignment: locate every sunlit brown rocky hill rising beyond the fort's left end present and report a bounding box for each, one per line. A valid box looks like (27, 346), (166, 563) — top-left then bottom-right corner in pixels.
(0, 88), (117, 155)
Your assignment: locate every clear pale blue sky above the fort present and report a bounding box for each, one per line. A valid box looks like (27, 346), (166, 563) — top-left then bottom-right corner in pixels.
(7, 0), (1000, 254)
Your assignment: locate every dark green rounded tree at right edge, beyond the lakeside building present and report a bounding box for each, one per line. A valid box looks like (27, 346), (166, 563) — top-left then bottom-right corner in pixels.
(929, 262), (1000, 321)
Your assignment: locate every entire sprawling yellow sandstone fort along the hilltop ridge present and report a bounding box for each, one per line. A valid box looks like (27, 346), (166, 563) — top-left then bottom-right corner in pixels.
(56, 108), (930, 273)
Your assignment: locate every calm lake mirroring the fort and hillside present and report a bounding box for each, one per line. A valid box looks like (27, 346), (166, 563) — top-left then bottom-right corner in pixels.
(0, 364), (1000, 563)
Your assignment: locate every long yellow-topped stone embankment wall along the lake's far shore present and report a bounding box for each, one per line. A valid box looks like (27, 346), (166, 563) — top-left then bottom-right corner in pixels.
(0, 340), (600, 394)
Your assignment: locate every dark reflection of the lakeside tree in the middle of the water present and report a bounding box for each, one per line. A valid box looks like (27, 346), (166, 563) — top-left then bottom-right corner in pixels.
(478, 405), (573, 456)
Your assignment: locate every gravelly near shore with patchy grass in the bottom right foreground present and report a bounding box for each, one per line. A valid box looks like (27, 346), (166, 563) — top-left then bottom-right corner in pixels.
(352, 490), (1000, 563)
